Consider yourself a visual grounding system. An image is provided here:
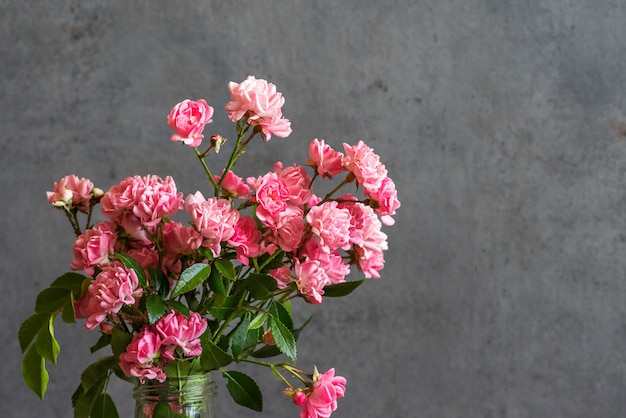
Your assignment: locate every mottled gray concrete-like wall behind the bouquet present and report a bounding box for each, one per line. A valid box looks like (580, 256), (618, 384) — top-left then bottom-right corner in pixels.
(0, 0), (626, 418)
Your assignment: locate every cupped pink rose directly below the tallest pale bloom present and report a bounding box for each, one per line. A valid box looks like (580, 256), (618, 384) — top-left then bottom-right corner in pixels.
(247, 173), (289, 225)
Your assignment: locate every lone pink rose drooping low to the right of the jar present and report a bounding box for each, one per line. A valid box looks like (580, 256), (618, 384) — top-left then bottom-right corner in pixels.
(294, 369), (346, 418)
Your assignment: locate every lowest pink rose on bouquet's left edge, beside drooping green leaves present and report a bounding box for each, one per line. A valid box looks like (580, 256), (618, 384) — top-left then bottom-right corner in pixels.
(76, 261), (142, 330)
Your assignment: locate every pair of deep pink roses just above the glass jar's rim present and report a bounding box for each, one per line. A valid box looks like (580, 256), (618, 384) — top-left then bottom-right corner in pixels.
(120, 310), (207, 383)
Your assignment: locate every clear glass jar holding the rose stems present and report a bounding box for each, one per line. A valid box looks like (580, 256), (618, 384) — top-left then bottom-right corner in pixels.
(133, 373), (217, 418)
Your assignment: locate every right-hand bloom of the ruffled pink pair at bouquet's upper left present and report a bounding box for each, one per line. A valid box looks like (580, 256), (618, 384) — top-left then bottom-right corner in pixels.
(132, 175), (183, 227)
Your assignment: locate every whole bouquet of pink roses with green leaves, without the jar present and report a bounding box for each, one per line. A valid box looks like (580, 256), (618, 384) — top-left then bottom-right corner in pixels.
(19, 76), (400, 418)
